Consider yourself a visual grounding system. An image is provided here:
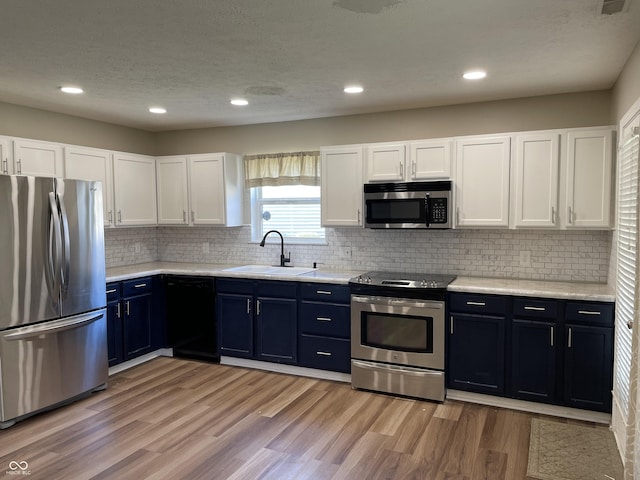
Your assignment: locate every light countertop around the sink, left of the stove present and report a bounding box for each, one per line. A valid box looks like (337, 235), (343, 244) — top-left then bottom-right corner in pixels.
(107, 262), (364, 285)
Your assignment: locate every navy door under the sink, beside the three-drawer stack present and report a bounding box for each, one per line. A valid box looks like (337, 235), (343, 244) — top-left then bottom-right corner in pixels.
(255, 297), (298, 364)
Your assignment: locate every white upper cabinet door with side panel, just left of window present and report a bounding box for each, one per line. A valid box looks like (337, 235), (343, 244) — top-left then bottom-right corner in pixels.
(188, 153), (244, 227)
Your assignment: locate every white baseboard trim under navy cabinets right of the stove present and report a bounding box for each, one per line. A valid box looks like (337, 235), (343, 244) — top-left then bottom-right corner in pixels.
(447, 390), (611, 425)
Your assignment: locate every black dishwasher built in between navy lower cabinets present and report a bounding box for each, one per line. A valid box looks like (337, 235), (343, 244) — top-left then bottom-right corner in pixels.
(164, 275), (220, 362)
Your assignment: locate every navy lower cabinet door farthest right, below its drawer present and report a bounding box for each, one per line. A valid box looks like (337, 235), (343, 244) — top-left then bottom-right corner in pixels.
(564, 324), (613, 412)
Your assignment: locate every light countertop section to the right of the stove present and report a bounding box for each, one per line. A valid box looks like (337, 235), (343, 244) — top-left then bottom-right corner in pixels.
(448, 277), (616, 302)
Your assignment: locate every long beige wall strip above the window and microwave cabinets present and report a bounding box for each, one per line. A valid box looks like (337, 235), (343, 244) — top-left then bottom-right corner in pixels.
(157, 90), (612, 155)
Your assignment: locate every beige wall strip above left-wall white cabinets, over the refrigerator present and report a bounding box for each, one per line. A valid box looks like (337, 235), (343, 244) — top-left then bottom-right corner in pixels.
(0, 103), (156, 155)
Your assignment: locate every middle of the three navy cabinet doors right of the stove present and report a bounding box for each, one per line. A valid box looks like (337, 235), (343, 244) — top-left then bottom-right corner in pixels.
(511, 319), (557, 403)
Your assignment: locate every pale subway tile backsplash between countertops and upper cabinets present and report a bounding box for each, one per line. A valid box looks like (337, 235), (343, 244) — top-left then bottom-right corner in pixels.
(105, 226), (612, 283)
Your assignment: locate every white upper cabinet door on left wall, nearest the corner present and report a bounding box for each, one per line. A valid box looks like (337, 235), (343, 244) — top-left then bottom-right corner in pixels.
(113, 152), (158, 226)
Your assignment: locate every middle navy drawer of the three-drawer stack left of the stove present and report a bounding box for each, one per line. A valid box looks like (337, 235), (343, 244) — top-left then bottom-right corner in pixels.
(300, 302), (351, 338)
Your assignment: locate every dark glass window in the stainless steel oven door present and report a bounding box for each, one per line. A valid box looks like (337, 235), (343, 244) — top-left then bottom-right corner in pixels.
(362, 312), (433, 353)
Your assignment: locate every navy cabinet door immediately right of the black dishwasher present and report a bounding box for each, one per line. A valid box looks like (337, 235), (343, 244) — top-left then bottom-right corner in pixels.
(216, 293), (253, 358)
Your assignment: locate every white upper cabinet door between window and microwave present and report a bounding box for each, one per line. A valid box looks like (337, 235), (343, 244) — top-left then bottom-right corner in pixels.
(320, 147), (363, 227)
